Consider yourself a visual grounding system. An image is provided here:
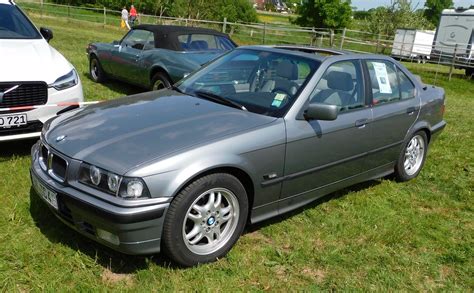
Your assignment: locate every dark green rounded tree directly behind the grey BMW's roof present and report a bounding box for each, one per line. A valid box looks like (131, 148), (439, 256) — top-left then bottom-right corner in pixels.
(295, 0), (352, 29)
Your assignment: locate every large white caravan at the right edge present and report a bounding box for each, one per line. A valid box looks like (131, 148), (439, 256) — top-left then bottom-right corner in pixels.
(431, 9), (474, 76)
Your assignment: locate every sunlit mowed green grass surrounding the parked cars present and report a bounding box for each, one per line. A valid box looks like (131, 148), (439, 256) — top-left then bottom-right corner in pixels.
(0, 17), (474, 292)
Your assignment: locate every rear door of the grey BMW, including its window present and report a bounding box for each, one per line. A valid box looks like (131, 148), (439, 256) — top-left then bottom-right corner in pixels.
(364, 59), (420, 168)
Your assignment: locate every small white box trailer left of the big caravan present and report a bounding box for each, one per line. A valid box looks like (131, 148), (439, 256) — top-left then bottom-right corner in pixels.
(392, 29), (435, 63)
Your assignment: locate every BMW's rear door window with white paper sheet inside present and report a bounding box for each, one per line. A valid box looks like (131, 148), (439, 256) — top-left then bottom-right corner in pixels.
(366, 60), (400, 105)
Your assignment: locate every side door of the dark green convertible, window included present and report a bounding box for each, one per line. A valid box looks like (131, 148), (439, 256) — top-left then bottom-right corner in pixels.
(112, 29), (154, 83)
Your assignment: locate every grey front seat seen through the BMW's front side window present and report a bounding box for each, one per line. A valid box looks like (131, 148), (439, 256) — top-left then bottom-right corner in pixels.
(313, 71), (354, 107)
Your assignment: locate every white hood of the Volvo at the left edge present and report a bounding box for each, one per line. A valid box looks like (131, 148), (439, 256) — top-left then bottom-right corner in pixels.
(0, 39), (72, 84)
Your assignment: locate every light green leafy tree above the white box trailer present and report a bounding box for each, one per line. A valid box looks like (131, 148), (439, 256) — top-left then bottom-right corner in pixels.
(366, 0), (432, 36)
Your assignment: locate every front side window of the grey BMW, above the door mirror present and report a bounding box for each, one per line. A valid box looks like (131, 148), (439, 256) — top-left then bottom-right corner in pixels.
(310, 60), (365, 111)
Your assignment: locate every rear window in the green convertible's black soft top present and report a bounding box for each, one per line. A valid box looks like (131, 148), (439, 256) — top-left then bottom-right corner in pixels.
(178, 33), (235, 51)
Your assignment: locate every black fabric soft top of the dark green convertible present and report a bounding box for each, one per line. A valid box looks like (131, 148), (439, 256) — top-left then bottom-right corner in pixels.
(132, 24), (237, 51)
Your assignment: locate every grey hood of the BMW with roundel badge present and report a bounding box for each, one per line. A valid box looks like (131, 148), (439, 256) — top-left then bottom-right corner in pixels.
(46, 90), (275, 174)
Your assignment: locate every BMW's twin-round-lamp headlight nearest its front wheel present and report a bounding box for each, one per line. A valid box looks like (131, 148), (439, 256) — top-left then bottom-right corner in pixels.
(79, 163), (150, 199)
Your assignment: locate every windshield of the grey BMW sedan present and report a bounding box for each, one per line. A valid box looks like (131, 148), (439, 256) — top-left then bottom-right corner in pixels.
(177, 49), (320, 117)
